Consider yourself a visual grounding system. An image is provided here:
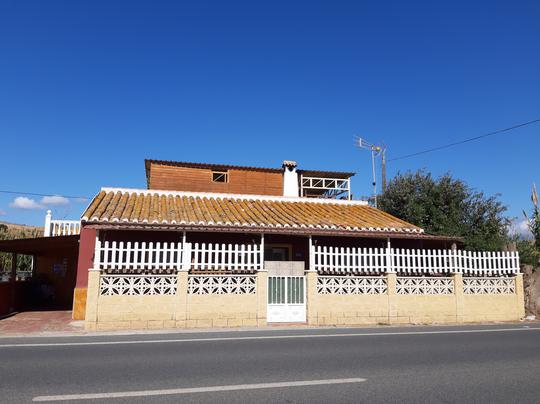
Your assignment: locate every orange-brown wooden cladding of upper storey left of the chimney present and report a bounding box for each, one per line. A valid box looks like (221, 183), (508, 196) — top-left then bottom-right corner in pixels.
(148, 164), (283, 196)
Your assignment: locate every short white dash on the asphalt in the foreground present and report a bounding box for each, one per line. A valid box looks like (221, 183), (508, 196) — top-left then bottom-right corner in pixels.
(32, 377), (366, 401)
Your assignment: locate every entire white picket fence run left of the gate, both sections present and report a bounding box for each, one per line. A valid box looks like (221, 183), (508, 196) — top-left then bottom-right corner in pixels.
(94, 239), (263, 272)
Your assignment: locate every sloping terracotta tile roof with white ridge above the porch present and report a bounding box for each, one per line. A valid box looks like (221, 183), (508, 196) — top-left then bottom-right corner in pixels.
(82, 188), (423, 234)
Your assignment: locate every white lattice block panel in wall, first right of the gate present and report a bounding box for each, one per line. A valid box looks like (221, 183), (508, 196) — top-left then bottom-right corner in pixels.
(317, 276), (387, 295)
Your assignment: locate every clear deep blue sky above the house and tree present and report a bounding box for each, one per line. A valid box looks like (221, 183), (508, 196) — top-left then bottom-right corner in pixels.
(0, 0), (540, 230)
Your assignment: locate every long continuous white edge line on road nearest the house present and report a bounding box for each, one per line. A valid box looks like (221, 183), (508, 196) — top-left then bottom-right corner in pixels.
(0, 328), (540, 348)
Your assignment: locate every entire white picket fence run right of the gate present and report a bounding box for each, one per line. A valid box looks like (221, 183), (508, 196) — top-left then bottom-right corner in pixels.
(310, 246), (519, 276)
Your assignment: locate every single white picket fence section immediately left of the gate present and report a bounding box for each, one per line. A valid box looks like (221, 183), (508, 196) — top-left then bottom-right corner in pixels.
(191, 243), (263, 272)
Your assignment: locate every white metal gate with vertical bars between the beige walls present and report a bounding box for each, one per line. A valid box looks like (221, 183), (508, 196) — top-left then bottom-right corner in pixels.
(266, 276), (306, 323)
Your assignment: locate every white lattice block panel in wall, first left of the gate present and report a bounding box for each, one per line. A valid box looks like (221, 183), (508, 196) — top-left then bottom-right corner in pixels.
(188, 275), (257, 295)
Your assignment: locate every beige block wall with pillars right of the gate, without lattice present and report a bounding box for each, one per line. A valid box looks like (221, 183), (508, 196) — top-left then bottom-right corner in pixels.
(307, 273), (525, 325)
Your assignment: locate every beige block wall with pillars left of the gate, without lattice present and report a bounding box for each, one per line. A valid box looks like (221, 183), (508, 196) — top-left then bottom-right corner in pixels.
(85, 271), (267, 330)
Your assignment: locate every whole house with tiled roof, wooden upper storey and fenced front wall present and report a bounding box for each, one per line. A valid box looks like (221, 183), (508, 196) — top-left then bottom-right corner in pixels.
(63, 160), (524, 330)
